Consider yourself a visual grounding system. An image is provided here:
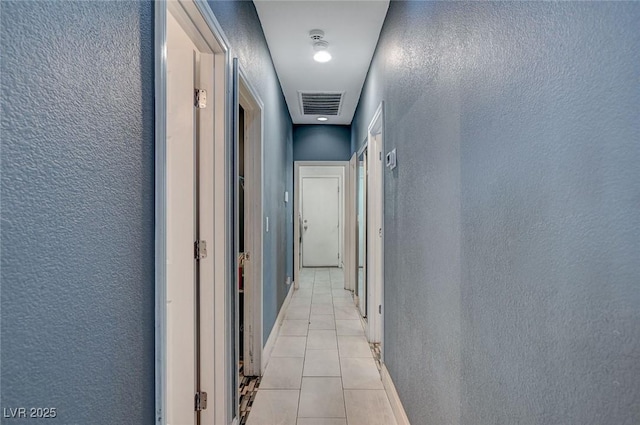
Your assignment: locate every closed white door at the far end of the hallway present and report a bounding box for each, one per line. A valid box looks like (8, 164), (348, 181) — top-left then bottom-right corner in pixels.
(302, 177), (341, 267)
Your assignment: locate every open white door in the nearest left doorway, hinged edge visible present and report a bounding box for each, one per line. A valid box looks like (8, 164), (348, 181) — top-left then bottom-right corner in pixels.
(166, 10), (196, 424)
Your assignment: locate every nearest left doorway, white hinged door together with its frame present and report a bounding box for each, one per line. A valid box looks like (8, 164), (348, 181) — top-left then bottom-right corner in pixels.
(160, 0), (234, 425)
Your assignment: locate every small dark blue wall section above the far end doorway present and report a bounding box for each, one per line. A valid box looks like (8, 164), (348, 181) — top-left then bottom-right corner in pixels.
(293, 125), (351, 161)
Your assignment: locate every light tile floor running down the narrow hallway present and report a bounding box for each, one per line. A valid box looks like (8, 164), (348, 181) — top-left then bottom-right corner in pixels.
(247, 269), (396, 425)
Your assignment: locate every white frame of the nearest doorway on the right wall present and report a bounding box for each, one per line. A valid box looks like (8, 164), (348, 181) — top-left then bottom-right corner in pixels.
(366, 102), (385, 346)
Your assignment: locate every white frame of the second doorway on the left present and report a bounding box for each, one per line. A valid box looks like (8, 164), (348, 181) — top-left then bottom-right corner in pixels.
(236, 65), (264, 376)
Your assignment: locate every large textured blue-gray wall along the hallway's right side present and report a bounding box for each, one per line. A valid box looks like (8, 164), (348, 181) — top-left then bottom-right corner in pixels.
(352, 2), (640, 425)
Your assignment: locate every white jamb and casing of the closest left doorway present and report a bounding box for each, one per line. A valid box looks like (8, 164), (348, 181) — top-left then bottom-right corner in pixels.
(154, 0), (231, 425)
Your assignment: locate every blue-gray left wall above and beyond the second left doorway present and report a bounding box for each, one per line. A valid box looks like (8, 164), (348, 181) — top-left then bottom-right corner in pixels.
(209, 1), (293, 342)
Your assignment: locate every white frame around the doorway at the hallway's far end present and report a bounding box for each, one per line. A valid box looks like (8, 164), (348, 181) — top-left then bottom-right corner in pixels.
(293, 161), (349, 289)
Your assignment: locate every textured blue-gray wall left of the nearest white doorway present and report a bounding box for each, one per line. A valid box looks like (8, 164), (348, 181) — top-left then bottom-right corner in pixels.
(0, 1), (154, 425)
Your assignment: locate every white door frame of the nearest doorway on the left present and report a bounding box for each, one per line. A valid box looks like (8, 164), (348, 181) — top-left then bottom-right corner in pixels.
(154, 0), (237, 425)
